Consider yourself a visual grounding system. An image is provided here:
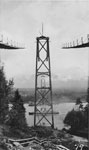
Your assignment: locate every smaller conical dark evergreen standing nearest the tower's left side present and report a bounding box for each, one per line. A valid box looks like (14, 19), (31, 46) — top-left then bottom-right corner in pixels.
(9, 90), (27, 129)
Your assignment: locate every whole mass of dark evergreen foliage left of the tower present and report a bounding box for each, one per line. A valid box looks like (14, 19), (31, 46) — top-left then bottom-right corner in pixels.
(0, 67), (27, 132)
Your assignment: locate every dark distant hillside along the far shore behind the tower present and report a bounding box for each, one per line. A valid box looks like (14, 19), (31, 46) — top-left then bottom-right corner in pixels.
(19, 84), (87, 103)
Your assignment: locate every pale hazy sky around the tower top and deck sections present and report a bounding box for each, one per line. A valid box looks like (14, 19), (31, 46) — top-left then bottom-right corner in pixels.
(0, 0), (89, 87)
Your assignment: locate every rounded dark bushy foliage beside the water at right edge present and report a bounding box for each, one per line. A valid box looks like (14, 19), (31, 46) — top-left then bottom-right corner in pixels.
(64, 104), (89, 130)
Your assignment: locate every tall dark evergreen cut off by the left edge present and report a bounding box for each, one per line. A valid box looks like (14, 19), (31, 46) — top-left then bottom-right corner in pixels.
(0, 66), (13, 123)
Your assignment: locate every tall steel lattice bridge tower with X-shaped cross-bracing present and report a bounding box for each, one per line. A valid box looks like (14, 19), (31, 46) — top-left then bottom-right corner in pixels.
(34, 35), (54, 128)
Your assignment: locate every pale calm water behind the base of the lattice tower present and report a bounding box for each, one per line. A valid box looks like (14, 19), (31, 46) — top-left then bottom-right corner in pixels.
(25, 103), (75, 129)
